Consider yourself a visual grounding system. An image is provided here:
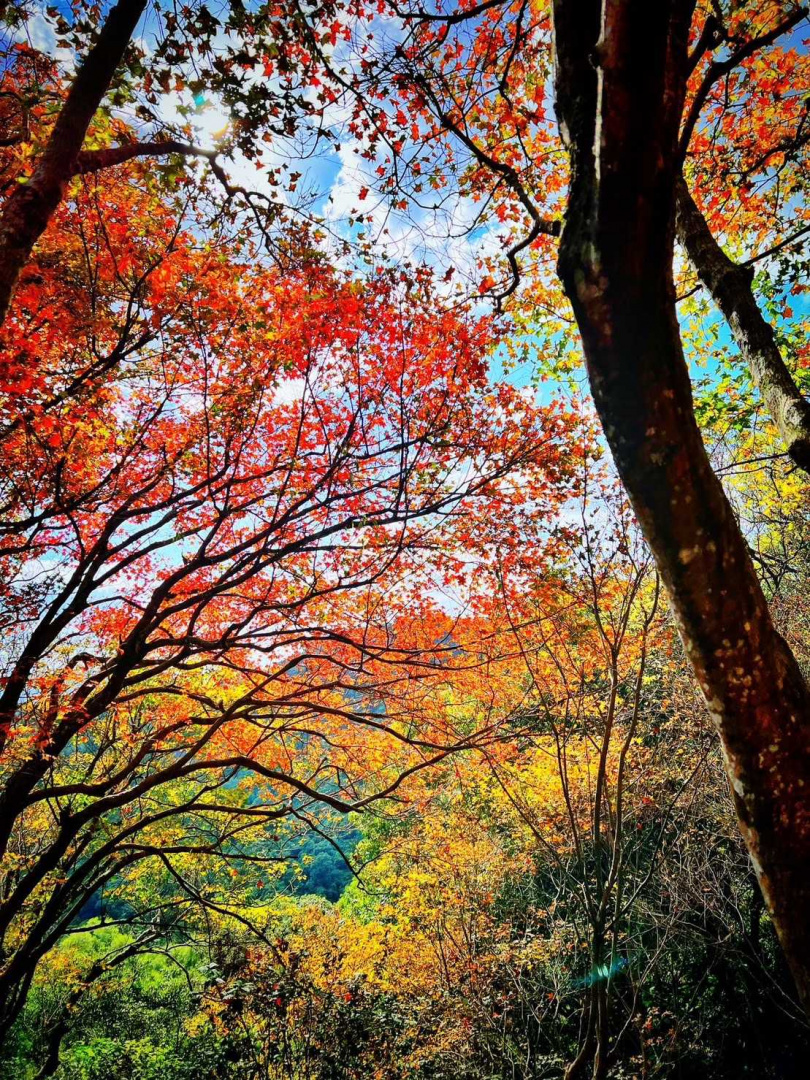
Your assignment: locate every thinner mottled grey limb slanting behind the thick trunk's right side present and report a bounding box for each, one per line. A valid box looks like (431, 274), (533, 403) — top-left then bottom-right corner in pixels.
(675, 177), (810, 472)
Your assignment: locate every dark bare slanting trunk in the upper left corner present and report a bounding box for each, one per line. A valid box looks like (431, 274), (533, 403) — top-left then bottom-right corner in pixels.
(0, 0), (146, 325)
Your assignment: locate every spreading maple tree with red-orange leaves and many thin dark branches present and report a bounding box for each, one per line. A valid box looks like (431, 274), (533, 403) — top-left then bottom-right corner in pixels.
(0, 97), (577, 1041)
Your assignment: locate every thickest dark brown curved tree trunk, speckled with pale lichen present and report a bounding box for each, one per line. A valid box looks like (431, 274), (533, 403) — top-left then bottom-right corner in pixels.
(554, 0), (810, 1009)
